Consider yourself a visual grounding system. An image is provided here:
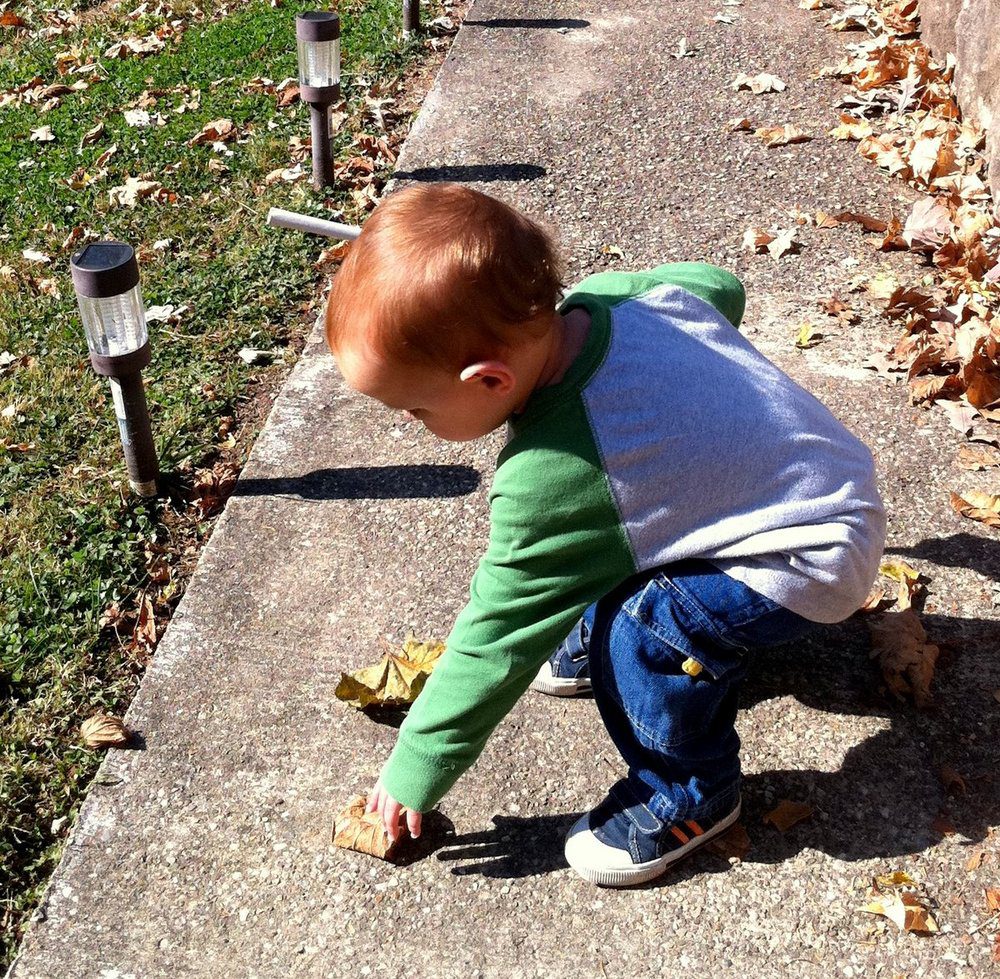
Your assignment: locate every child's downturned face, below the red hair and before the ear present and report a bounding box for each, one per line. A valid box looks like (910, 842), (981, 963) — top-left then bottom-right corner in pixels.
(334, 344), (512, 442)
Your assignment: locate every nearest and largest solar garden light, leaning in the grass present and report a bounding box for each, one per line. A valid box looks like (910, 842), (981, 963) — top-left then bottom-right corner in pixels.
(70, 241), (160, 497)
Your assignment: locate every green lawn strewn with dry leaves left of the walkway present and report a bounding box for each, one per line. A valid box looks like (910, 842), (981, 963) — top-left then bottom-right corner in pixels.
(0, 0), (442, 968)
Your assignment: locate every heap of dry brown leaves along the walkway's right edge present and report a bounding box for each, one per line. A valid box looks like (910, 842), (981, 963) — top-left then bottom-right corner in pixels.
(824, 0), (1000, 468)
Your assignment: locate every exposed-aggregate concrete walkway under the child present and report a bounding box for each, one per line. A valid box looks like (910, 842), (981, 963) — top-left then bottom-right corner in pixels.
(11, 0), (1000, 979)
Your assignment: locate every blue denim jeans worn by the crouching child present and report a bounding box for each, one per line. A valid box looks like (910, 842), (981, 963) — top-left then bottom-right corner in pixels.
(583, 560), (815, 822)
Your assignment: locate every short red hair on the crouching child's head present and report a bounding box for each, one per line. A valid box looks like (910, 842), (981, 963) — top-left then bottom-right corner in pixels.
(326, 183), (562, 369)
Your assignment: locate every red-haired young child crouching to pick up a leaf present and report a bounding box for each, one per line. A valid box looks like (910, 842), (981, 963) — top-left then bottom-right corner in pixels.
(326, 184), (885, 886)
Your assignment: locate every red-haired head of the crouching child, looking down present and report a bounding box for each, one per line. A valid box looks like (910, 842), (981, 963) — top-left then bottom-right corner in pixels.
(326, 184), (561, 439)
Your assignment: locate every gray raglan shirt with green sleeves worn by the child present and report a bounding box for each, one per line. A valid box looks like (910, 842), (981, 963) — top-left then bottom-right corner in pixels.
(383, 263), (885, 810)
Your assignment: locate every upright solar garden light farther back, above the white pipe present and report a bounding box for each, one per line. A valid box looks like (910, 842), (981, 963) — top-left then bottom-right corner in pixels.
(295, 10), (340, 190)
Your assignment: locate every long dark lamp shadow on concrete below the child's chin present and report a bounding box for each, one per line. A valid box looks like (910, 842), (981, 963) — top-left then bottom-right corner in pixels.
(233, 465), (480, 500)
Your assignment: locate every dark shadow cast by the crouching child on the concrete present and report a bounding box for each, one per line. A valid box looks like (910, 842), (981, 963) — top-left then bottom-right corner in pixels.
(438, 615), (1000, 887)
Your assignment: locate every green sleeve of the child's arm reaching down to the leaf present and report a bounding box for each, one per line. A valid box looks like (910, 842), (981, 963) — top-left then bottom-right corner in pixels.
(382, 398), (635, 811)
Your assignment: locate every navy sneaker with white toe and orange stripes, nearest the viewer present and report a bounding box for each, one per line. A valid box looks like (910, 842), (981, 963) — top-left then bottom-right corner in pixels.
(566, 779), (740, 887)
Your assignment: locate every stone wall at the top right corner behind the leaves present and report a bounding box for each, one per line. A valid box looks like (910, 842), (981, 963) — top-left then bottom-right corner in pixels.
(920, 0), (1000, 213)
